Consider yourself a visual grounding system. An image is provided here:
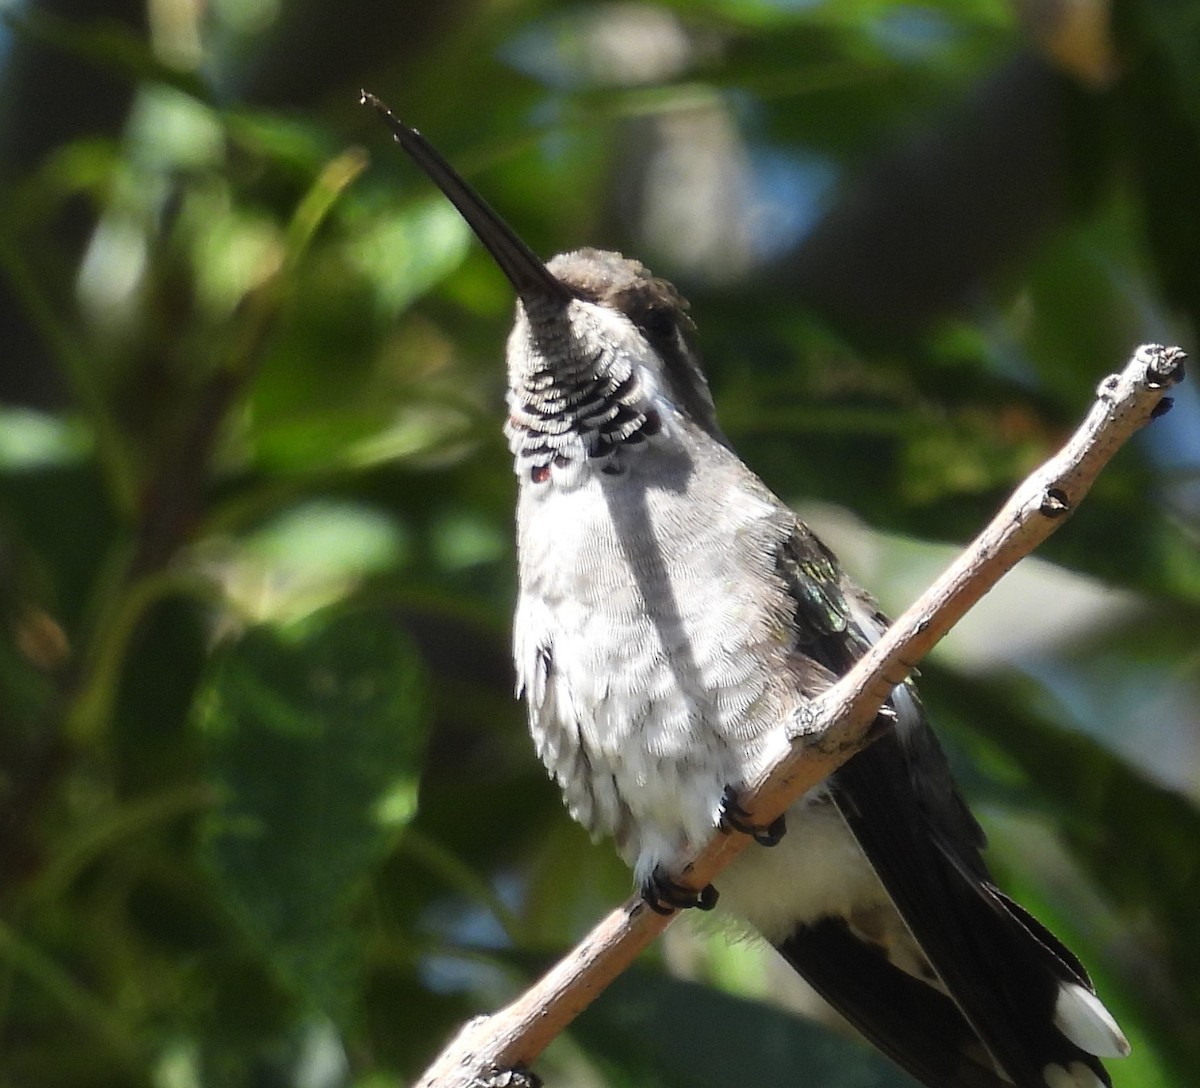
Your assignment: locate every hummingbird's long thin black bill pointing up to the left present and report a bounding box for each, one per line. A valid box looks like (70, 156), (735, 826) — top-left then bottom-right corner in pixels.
(359, 91), (572, 303)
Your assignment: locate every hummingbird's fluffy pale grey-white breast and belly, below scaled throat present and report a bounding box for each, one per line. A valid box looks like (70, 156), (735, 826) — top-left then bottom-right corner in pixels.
(515, 417), (798, 879)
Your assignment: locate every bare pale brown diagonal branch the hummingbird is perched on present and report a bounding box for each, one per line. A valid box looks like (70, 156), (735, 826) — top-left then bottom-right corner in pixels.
(418, 344), (1186, 1088)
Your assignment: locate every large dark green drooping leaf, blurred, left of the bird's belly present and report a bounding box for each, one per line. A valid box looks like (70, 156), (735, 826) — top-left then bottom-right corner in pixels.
(198, 613), (426, 1016)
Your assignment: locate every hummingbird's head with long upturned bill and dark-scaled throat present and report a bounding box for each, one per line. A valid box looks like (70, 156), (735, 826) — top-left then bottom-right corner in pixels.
(364, 94), (725, 482)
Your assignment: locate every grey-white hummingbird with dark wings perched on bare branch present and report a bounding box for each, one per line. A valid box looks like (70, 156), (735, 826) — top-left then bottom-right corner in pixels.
(362, 92), (1129, 1088)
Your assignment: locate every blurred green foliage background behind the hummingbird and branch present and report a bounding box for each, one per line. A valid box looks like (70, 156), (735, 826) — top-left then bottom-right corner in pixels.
(0, 0), (1200, 1088)
